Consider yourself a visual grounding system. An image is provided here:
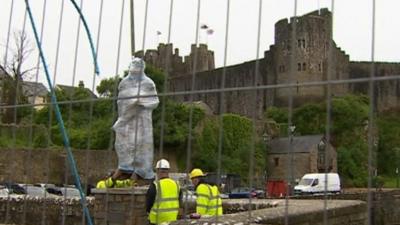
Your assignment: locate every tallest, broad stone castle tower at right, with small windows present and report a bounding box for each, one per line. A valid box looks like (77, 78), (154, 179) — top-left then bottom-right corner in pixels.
(273, 9), (348, 104)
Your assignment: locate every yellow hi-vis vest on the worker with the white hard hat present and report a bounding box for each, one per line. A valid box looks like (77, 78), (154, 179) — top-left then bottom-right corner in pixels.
(149, 178), (179, 224)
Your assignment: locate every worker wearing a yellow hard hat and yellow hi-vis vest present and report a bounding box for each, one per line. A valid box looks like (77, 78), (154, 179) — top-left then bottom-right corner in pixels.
(190, 168), (223, 217)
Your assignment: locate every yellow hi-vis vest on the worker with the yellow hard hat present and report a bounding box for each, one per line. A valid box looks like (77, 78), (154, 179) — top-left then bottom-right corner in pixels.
(196, 184), (223, 216)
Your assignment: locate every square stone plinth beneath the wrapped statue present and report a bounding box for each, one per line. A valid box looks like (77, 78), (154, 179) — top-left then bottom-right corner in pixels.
(92, 187), (148, 225)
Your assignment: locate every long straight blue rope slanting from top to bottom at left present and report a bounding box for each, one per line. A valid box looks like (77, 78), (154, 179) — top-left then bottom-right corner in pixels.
(25, 0), (93, 225)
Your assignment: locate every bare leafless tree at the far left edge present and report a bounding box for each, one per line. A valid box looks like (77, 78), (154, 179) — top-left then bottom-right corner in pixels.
(0, 32), (37, 123)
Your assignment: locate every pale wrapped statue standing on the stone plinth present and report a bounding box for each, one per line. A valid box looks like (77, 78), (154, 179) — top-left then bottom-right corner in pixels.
(113, 58), (159, 179)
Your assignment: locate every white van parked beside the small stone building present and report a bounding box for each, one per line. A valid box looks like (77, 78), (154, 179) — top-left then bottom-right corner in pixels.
(294, 173), (340, 194)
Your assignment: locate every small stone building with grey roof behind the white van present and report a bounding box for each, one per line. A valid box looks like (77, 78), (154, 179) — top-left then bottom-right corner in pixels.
(267, 135), (337, 181)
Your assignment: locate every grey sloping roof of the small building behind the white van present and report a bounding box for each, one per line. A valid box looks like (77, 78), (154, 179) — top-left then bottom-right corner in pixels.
(269, 134), (324, 154)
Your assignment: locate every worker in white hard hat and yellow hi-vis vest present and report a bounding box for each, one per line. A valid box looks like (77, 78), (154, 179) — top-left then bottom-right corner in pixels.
(146, 159), (182, 224)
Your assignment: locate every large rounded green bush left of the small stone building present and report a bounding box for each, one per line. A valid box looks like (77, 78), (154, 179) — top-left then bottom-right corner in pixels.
(193, 114), (265, 181)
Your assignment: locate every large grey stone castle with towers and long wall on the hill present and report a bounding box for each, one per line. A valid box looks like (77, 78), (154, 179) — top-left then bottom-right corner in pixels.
(137, 9), (400, 116)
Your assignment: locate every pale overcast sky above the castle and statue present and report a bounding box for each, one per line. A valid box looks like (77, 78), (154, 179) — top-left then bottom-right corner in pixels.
(0, 0), (400, 93)
